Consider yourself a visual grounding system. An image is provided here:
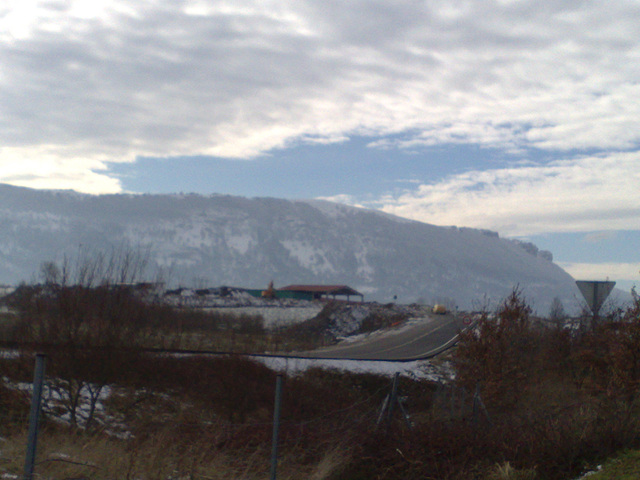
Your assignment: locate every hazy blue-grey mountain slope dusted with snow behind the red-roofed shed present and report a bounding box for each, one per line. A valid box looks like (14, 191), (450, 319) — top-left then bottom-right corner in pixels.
(0, 185), (579, 314)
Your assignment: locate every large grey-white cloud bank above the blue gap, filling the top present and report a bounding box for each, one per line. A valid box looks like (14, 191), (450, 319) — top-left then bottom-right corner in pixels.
(0, 0), (640, 192)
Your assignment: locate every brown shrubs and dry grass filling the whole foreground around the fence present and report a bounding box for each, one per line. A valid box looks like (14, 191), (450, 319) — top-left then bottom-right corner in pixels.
(0, 272), (640, 480)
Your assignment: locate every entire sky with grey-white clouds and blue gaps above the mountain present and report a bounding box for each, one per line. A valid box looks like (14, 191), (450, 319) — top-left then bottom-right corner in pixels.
(0, 0), (640, 287)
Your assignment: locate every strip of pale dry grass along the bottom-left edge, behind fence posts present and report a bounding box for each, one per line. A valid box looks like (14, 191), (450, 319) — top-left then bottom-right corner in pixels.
(0, 430), (346, 480)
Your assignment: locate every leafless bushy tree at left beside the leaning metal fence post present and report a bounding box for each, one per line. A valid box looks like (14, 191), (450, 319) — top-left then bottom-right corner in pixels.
(14, 248), (157, 428)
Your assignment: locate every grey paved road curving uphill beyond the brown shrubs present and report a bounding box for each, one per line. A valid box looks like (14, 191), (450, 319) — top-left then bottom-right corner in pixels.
(292, 315), (464, 360)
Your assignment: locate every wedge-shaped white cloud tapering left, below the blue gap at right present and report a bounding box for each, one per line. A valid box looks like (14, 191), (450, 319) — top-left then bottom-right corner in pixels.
(378, 152), (640, 236)
